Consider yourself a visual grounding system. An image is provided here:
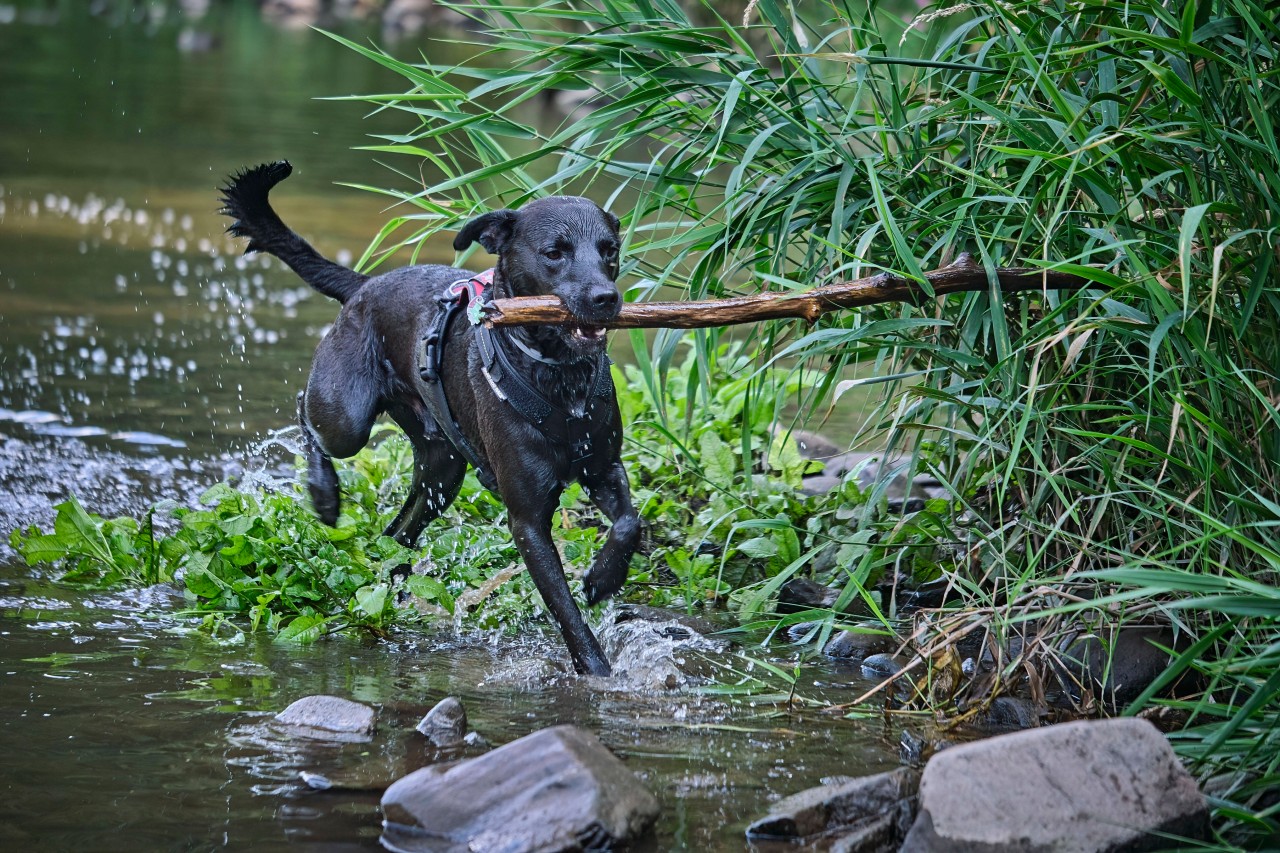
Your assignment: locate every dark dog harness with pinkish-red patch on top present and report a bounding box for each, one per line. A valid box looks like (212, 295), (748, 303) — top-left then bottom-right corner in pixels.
(417, 269), (613, 492)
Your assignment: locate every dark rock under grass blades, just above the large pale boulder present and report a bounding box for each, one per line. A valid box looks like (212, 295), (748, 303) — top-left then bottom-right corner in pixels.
(1059, 628), (1179, 710)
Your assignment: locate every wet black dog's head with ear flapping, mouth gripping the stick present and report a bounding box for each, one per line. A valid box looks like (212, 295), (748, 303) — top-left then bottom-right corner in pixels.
(453, 196), (622, 352)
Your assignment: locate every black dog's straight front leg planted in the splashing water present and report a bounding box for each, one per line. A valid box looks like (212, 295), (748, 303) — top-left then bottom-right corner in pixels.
(508, 496), (612, 675)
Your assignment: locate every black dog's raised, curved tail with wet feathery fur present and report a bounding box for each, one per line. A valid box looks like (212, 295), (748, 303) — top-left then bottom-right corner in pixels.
(219, 160), (369, 302)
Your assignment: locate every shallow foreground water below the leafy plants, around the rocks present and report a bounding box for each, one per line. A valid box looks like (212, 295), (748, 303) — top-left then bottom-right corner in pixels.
(0, 560), (896, 850)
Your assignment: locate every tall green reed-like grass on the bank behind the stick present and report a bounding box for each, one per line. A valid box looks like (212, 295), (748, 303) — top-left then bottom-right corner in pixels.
(348, 0), (1280, 833)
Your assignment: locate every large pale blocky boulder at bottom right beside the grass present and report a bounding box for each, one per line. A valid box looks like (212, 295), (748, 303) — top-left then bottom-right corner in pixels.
(901, 719), (1208, 853)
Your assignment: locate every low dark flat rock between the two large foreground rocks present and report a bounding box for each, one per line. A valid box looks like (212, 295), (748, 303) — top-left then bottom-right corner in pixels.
(746, 767), (920, 853)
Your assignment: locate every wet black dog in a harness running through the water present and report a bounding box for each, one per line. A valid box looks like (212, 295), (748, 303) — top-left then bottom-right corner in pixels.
(221, 163), (640, 675)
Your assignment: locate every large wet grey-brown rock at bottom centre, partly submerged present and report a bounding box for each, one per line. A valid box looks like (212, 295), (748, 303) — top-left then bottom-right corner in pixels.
(381, 726), (658, 853)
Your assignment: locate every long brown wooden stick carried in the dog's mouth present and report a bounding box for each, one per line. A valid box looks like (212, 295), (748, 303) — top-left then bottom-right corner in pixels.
(485, 252), (1093, 329)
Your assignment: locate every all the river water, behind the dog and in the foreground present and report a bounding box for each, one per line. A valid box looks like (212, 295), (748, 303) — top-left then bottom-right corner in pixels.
(0, 1), (896, 850)
